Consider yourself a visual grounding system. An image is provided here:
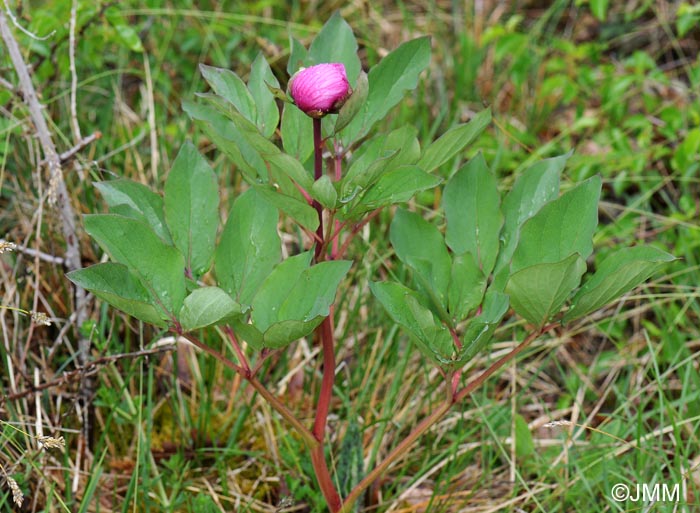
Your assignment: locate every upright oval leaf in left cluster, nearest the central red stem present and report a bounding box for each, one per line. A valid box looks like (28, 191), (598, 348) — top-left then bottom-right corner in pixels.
(214, 189), (282, 305)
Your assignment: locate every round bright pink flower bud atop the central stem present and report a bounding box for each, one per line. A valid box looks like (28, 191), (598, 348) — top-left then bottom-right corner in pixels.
(289, 62), (352, 118)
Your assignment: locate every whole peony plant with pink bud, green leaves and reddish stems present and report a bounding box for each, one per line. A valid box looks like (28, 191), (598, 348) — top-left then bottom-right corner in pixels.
(68, 14), (673, 513)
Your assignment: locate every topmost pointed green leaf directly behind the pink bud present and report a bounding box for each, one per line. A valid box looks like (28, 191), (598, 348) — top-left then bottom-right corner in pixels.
(306, 11), (362, 84)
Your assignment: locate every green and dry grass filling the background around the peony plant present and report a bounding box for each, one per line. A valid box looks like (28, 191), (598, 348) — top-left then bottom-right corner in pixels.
(0, 0), (700, 513)
